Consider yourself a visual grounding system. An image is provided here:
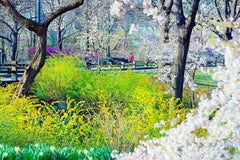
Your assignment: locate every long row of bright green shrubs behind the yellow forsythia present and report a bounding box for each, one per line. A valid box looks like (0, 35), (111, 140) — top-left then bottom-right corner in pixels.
(32, 57), (176, 108)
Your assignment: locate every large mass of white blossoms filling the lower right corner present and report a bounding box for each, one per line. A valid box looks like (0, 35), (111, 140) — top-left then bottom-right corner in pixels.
(113, 22), (240, 160)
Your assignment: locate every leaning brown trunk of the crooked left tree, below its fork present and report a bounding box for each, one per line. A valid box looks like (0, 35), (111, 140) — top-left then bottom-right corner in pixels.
(17, 29), (47, 96)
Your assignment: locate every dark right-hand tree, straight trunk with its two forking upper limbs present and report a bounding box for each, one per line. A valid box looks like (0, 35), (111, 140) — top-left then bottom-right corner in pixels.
(171, 0), (200, 100)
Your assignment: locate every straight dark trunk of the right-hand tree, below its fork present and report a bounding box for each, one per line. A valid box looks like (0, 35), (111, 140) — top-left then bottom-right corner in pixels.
(171, 26), (192, 100)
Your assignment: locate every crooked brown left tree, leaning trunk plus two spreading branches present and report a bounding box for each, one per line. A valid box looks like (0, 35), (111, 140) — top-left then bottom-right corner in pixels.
(0, 0), (83, 95)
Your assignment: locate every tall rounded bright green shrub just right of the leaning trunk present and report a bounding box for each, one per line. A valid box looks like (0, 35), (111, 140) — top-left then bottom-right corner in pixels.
(32, 56), (86, 101)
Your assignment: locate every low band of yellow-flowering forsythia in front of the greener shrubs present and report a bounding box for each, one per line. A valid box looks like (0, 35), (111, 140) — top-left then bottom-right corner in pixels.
(0, 85), (187, 151)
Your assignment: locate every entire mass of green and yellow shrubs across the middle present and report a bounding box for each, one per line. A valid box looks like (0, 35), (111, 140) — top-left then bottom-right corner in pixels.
(0, 57), (188, 154)
